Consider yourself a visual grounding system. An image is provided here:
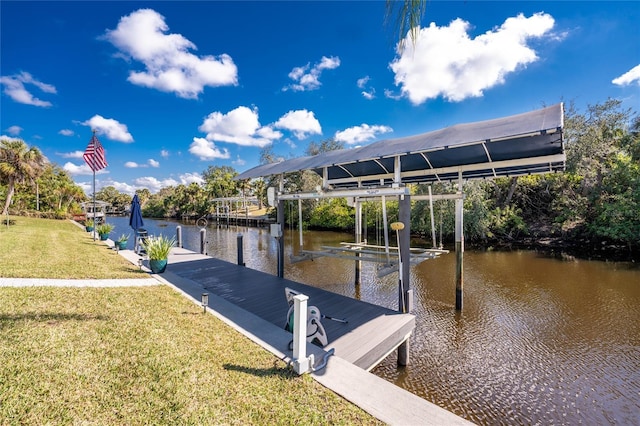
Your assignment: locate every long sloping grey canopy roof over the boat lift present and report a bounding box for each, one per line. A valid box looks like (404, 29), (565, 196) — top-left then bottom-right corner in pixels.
(236, 103), (565, 187)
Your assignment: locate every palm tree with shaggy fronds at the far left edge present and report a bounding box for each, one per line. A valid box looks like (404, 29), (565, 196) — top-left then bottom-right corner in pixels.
(0, 139), (47, 215)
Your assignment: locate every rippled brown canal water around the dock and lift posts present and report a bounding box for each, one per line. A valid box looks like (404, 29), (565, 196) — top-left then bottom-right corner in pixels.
(109, 218), (640, 425)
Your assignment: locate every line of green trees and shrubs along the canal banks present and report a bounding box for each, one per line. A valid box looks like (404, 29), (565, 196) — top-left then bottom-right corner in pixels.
(0, 99), (640, 258)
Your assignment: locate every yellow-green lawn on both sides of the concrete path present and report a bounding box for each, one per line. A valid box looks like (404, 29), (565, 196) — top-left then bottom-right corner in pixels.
(0, 218), (380, 425)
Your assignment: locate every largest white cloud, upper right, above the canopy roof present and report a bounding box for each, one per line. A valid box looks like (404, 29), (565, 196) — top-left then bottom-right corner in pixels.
(390, 13), (554, 105)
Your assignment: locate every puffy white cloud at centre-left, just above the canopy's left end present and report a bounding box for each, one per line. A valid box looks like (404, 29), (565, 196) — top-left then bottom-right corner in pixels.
(199, 106), (282, 147)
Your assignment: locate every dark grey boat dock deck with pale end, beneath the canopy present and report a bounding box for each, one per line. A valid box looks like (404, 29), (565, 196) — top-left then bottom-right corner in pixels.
(167, 249), (415, 370)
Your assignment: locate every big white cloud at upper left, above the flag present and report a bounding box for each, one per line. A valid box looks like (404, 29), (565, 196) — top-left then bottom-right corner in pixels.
(104, 9), (238, 99)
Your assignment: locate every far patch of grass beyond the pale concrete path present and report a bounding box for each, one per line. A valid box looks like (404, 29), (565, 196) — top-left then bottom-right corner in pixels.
(0, 216), (144, 279)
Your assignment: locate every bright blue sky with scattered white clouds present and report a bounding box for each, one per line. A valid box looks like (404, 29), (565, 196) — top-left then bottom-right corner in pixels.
(0, 0), (640, 193)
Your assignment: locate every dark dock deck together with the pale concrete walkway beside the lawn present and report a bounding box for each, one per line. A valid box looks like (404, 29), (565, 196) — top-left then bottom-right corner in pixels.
(120, 248), (471, 425)
